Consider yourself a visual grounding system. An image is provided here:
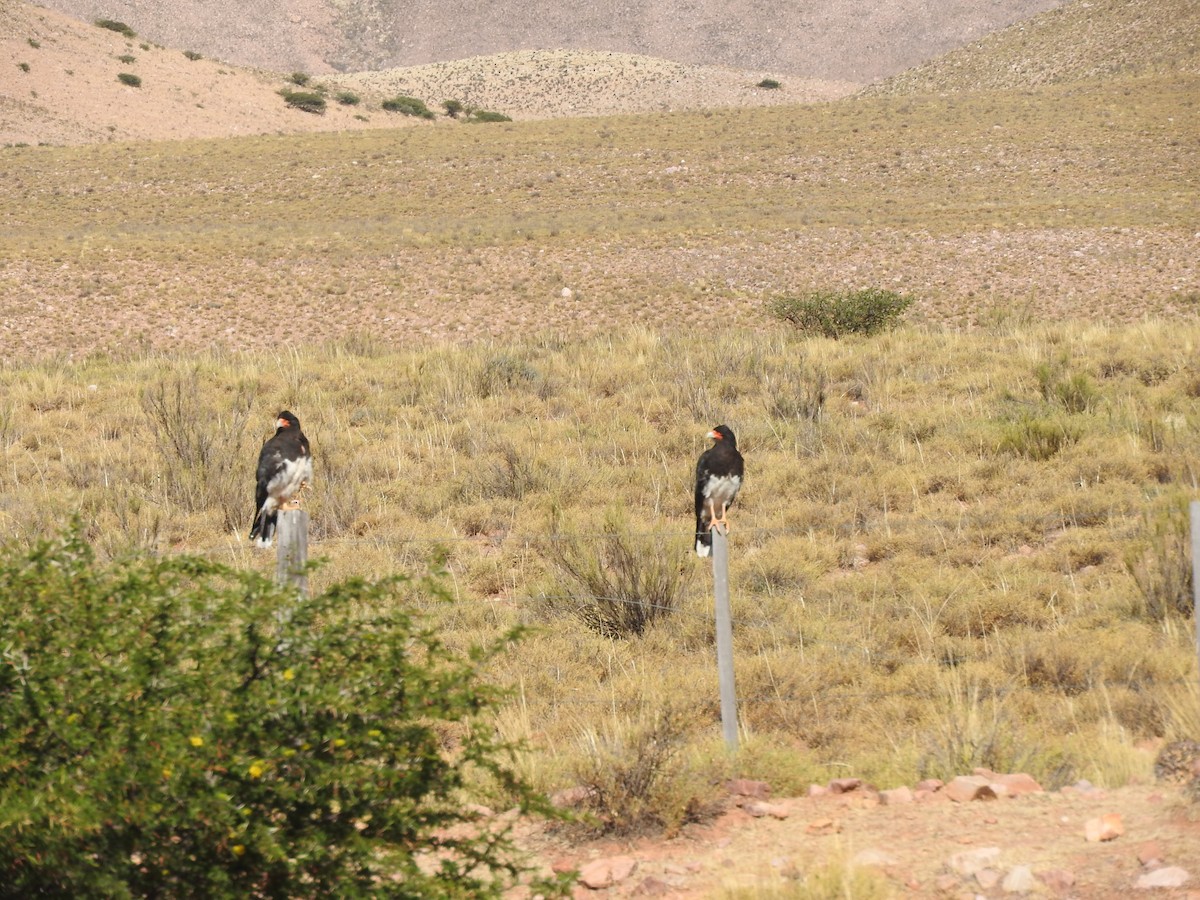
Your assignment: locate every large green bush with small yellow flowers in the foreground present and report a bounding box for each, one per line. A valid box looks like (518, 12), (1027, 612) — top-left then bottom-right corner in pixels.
(0, 523), (564, 898)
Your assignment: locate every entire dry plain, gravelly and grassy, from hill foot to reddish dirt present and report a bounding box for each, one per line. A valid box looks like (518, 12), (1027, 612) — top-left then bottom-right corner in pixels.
(0, 5), (1200, 896)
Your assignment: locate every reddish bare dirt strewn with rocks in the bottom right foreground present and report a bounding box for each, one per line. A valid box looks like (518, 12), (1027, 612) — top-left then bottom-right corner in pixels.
(527, 785), (1200, 900)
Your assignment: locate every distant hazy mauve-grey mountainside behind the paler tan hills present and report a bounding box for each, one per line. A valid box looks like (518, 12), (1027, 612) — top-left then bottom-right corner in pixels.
(28, 0), (1061, 84)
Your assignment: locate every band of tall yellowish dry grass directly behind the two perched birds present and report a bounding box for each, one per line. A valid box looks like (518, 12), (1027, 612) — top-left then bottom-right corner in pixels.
(0, 320), (1200, 801)
